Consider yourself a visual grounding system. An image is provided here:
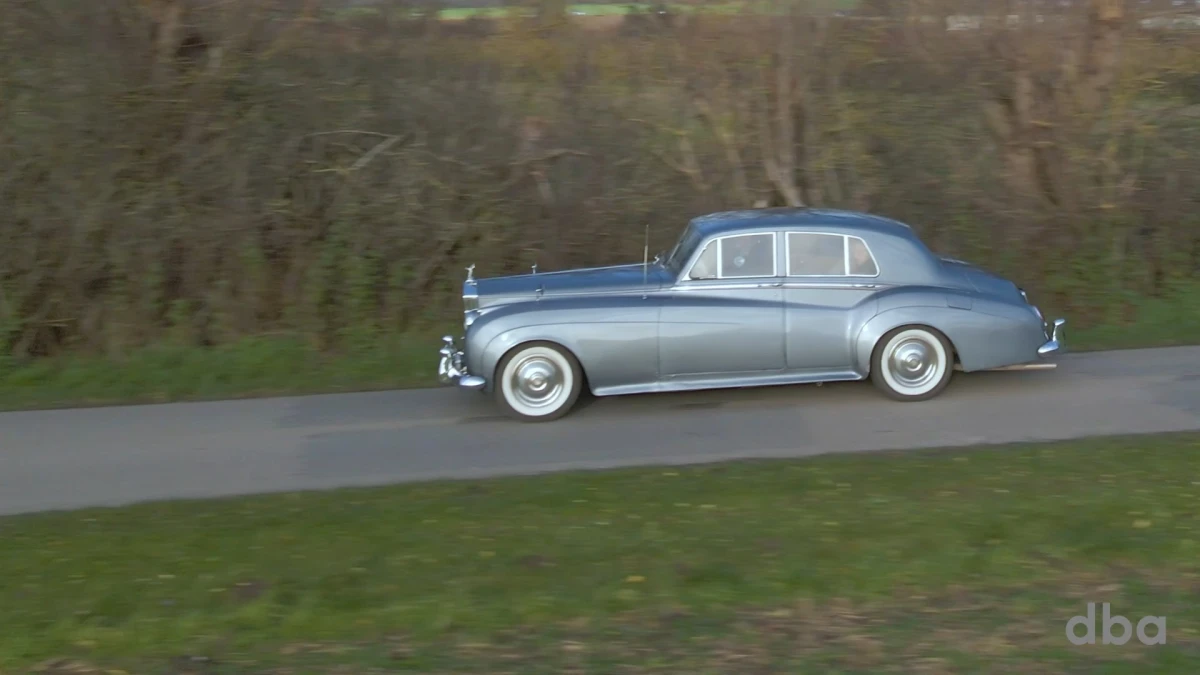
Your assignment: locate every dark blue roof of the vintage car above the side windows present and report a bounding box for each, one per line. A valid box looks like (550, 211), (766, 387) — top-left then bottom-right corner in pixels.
(691, 207), (914, 238)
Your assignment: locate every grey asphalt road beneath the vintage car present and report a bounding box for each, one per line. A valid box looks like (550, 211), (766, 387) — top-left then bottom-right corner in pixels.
(0, 347), (1200, 514)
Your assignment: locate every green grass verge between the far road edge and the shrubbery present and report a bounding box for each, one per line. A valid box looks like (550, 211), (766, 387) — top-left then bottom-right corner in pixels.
(0, 282), (1200, 410)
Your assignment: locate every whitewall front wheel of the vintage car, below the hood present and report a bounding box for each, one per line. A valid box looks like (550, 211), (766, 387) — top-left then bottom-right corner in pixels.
(496, 342), (583, 422)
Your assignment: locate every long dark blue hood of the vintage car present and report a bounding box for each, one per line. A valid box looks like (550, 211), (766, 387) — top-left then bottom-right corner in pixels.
(476, 263), (668, 305)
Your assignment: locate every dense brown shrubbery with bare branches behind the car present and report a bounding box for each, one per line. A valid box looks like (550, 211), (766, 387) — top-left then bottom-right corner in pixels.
(0, 0), (1200, 357)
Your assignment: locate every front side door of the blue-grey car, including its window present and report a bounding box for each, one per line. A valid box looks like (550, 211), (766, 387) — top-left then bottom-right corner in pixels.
(659, 232), (786, 380)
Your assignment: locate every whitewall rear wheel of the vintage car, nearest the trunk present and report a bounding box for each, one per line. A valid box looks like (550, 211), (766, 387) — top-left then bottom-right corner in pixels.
(871, 325), (954, 401)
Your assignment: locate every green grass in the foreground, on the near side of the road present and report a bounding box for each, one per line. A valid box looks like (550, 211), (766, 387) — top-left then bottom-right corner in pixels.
(0, 434), (1200, 675)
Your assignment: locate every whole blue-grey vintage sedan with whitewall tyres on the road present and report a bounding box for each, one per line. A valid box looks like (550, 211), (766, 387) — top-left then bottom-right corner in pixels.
(438, 208), (1066, 422)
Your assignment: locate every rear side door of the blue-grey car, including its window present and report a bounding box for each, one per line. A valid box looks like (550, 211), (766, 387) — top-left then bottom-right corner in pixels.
(784, 231), (880, 372)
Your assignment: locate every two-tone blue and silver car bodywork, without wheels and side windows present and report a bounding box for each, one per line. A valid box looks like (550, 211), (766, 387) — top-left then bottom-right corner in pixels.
(443, 209), (1058, 396)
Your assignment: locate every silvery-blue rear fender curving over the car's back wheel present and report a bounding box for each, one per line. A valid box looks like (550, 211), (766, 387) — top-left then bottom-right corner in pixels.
(856, 298), (1045, 374)
